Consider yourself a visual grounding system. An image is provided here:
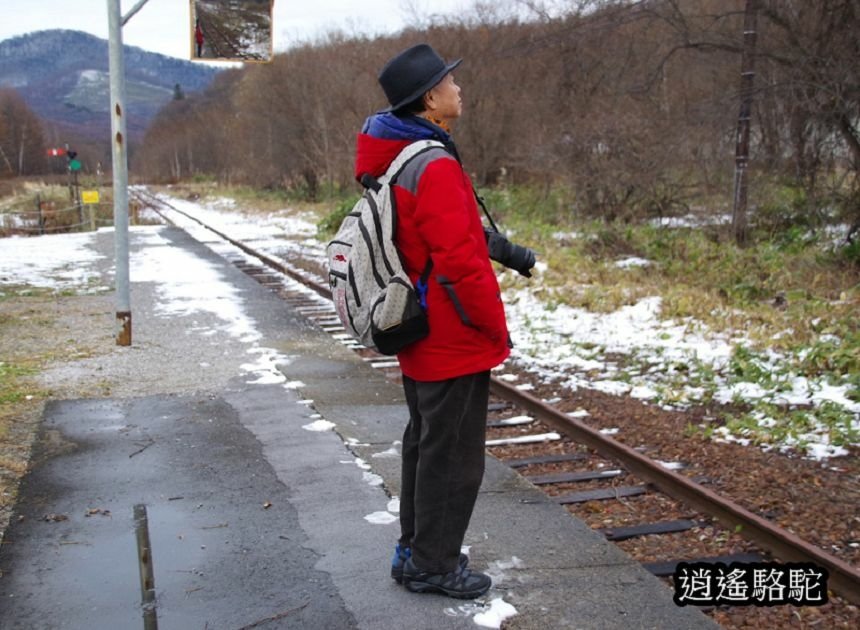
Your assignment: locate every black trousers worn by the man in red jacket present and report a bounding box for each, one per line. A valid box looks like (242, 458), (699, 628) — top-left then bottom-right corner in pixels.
(400, 371), (490, 573)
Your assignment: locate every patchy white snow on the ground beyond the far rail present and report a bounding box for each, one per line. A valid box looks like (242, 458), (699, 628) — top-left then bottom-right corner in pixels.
(149, 190), (860, 458)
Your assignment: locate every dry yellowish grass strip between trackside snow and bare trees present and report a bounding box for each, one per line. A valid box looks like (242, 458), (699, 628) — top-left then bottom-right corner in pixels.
(508, 217), (860, 350)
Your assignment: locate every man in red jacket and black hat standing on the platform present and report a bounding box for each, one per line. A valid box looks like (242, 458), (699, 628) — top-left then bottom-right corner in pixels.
(355, 44), (534, 599)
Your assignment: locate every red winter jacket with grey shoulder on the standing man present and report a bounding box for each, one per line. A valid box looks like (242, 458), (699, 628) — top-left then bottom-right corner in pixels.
(355, 133), (510, 381)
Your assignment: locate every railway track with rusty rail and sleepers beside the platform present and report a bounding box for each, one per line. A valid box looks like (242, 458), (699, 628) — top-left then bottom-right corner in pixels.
(134, 190), (860, 627)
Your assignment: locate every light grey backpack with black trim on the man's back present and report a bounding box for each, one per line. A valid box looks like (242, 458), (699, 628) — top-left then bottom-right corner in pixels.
(326, 140), (444, 354)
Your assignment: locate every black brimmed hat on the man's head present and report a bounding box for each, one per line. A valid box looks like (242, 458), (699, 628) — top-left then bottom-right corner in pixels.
(379, 44), (463, 112)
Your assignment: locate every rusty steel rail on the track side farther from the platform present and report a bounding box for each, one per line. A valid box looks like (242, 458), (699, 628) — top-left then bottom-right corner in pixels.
(135, 191), (860, 604)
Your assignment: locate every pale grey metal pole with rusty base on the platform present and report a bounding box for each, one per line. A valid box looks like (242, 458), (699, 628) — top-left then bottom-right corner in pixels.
(107, 0), (147, 346)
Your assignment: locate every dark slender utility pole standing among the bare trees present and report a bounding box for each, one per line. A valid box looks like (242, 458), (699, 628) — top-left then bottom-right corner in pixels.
(732, 0), (758, 245)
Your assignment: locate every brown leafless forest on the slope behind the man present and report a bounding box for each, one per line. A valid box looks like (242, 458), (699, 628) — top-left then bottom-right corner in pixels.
(132, 0), (860, 241)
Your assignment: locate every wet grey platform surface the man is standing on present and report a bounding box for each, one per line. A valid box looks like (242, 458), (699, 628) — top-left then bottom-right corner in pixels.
(0, 228), (716, 630)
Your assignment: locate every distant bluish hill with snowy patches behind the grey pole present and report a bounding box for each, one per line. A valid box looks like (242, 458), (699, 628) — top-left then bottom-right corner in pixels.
(0, 30), (218, 138)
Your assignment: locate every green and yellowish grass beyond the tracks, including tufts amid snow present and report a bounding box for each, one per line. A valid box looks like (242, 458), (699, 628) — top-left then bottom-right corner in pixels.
(470, 183), (860, 450)
